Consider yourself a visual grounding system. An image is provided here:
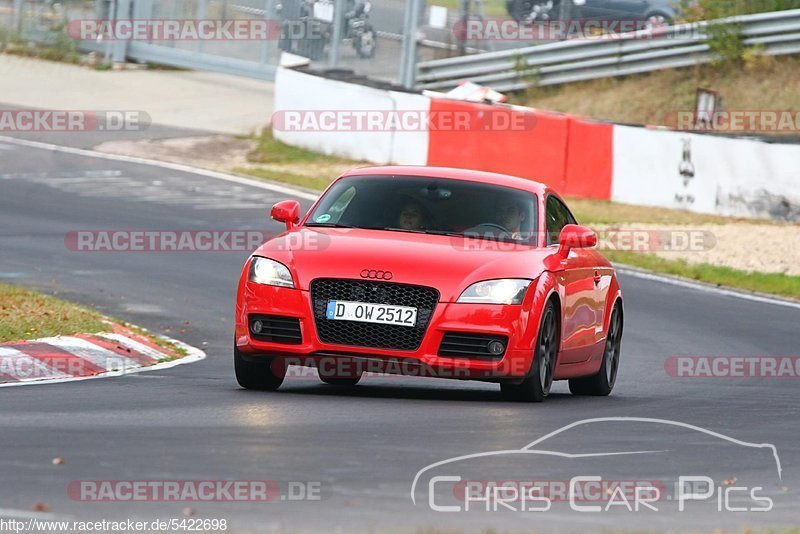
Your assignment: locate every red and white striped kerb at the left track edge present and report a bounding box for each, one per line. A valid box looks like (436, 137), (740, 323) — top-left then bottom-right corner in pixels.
(0, 328), (205, 387)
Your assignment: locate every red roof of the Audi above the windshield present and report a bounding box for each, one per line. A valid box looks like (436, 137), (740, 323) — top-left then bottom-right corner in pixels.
(341, 165), (554, 195)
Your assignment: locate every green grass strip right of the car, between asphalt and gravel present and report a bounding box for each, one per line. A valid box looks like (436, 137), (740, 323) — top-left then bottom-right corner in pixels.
(603, 251), (800, 299)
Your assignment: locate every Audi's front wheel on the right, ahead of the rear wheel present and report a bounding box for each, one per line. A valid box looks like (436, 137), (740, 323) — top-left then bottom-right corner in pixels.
(500, 301), (559, 402)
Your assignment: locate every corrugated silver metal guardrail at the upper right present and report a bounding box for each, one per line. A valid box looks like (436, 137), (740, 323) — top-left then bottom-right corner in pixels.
(416, 9), (800, 91)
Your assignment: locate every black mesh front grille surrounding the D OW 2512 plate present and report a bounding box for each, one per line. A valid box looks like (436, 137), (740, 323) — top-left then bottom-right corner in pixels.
(311, 278), (439, 350)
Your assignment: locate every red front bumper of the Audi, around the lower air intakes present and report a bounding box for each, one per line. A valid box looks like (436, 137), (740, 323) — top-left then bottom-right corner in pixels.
(235, 282), (539, 380)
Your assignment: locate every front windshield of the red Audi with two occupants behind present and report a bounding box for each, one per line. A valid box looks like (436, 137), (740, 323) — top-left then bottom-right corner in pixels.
(306, 176), (537, 245)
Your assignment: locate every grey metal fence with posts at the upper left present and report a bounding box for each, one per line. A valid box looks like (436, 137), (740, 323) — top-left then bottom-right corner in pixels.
(0, 0), (428, 85)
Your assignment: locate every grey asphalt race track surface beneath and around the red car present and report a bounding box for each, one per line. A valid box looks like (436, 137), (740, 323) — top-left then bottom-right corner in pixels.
(0, 140), (800, 532)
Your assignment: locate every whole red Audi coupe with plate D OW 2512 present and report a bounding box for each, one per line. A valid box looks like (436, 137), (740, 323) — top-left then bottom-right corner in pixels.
(234, 167), (623, 401)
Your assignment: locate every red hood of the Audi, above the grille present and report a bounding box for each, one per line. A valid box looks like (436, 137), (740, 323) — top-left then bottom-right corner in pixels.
(254, 227), (554, 302)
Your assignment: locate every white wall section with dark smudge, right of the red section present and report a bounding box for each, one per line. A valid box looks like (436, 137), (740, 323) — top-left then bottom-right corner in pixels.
(611, 126), (800, 218)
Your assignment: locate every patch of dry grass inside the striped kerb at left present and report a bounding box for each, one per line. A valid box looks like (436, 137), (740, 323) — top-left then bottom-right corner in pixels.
(0, 284), (111, 341)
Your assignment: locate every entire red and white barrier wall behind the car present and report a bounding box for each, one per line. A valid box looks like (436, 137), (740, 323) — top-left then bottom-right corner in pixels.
(273, 68), (800, 219)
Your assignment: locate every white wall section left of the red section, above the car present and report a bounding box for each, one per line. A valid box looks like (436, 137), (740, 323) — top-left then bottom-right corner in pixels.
(273, 68), (430, 165)
